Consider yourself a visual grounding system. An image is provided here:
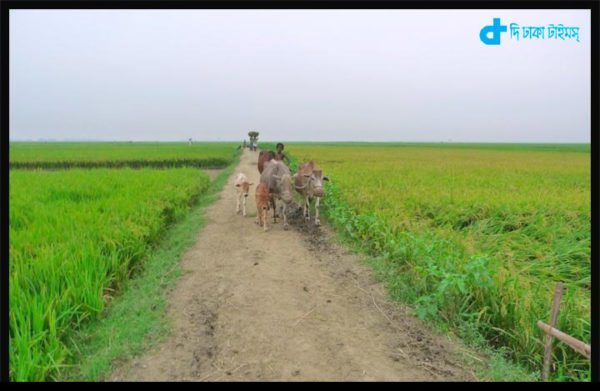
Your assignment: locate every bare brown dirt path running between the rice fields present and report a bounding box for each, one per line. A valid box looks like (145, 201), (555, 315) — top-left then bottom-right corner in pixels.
(110, 151), (474, 381)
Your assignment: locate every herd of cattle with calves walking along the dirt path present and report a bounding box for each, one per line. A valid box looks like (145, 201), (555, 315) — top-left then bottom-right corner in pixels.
(235, 151), (329, 231)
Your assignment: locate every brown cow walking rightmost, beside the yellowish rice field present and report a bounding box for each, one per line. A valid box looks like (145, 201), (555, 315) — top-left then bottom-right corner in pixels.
(293, 160), (329, 226)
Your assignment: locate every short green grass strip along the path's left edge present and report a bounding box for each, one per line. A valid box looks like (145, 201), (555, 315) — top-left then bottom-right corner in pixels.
(60, 156), (239, 381)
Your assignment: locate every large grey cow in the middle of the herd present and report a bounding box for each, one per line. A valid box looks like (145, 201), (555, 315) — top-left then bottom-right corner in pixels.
(260, 159), (294, 230)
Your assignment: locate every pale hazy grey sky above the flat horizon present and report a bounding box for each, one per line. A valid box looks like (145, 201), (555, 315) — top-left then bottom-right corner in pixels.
(9, 10), (591, 142)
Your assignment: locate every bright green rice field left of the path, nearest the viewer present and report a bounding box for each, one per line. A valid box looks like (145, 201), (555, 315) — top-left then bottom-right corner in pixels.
(9, 168), (209, 381)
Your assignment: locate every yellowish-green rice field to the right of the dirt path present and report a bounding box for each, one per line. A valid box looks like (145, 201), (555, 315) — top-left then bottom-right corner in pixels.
(286, 143), (591, 380)
